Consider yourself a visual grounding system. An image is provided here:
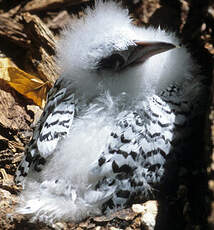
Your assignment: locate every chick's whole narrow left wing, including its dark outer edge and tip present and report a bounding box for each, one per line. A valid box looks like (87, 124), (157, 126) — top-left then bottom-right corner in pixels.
(15, 79), (75, 182)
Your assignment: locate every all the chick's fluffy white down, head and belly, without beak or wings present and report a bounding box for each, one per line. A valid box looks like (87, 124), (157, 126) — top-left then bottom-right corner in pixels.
(18, 1), (202, 223)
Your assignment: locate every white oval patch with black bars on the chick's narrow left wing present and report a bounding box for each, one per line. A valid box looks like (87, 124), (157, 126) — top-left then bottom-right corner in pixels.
(37, 88), (75, 158)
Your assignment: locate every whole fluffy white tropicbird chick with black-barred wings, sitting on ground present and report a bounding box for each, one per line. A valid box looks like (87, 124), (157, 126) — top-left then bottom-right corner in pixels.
(16, 1), (206, 222)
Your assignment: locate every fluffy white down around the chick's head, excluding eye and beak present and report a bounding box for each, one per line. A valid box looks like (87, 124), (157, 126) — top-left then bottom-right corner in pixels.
(56, 1), (197, 97)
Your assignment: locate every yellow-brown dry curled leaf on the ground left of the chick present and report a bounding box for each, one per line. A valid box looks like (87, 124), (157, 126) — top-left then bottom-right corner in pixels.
(0, 58), (51, 108)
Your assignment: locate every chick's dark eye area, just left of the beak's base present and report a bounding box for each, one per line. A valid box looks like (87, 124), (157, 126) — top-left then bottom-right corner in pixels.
(98, 53), (125, 71)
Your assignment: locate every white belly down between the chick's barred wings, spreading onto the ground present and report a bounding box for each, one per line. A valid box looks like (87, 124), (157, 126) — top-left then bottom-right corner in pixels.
(17, 94), (123, 223)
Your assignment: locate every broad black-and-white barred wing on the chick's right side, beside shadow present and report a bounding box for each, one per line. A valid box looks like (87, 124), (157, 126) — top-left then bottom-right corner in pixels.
(91, 97), (175, 209)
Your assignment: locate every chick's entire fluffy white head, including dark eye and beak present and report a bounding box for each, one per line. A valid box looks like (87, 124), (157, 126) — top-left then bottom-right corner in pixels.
(57, 1), (195, 99)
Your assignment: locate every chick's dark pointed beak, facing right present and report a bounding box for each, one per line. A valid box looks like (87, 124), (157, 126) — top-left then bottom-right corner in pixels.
(128, 41), (176, 64)
